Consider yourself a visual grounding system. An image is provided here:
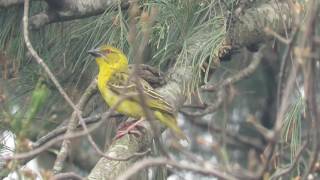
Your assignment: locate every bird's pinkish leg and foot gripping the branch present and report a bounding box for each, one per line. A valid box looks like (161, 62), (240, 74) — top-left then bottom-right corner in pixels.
(114, 118), (145, 139)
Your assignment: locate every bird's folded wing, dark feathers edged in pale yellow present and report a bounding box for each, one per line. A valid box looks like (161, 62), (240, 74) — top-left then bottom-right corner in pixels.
(107, 72), (174, 114)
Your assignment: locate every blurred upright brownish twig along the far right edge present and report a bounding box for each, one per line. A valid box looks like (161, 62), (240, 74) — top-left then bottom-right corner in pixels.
(298, 0), (320, 179)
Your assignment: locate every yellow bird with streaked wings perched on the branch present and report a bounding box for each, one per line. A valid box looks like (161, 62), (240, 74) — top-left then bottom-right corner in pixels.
(88, 45), (186, 139)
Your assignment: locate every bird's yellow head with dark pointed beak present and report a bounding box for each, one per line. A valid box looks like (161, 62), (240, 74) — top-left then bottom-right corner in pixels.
(88, 45), (128, 67)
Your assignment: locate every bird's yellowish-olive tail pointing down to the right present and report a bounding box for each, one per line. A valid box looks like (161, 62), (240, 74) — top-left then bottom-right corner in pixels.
(154, 111), (189, 141)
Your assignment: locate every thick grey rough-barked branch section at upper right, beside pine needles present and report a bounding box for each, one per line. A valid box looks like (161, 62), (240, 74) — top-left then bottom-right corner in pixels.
(228, 0), (292, 47)
